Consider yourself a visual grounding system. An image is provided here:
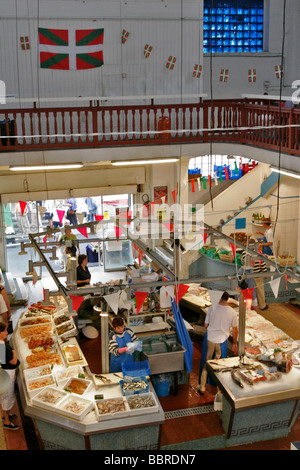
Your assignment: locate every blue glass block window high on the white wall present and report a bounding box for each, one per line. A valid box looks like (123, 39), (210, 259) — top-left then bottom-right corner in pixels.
(203, 0), (264, 54)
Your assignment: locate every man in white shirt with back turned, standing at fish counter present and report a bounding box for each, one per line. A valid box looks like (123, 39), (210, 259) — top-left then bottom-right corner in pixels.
(198, 292), (238, 395)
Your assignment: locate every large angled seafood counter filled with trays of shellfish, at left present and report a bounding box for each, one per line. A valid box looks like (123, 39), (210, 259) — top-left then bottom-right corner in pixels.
(12, 306), (165, 450)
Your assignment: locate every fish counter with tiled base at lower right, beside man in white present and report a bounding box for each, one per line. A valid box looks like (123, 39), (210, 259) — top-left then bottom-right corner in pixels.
(206, 357), (300, 447)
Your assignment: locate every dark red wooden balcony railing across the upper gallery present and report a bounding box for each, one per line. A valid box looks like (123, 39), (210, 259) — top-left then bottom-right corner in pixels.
(0, 100), (300, 155)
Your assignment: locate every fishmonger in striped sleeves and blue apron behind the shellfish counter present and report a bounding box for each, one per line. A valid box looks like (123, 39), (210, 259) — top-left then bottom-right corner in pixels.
(108, 315), (137, 373)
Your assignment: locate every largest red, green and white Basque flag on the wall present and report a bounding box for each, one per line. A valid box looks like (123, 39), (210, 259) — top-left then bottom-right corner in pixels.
(38, 28), (104, 70)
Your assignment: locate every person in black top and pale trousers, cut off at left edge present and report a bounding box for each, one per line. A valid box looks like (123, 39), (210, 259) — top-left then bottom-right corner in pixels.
(0, 323), (20, 431)
